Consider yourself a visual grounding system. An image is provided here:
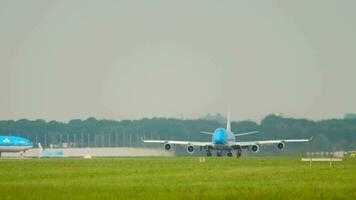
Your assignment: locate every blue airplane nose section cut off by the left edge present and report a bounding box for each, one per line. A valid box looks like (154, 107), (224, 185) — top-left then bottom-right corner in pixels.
(0, 136), (33, 157)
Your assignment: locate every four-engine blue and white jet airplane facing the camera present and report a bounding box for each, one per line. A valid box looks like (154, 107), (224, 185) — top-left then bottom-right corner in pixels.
(143, 111), (313, 157)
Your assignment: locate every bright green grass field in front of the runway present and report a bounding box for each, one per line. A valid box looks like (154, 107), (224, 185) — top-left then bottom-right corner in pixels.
(0, 157), (356, 200)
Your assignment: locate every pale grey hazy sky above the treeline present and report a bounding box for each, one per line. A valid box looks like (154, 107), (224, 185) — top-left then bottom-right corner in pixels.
(0, 0), (356, 121)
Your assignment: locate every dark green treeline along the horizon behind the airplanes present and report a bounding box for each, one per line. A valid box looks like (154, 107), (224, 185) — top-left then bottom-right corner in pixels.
(0, 115), (356, 152)
